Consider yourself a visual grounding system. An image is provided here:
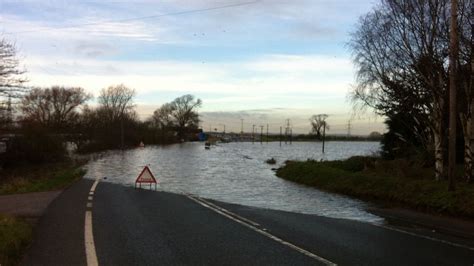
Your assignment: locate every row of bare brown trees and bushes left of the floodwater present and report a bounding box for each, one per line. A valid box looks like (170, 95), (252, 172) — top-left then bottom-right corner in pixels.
(0, 40), (202, 166)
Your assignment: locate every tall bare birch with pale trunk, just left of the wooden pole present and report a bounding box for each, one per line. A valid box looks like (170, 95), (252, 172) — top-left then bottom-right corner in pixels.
(350, 0), (472, 179)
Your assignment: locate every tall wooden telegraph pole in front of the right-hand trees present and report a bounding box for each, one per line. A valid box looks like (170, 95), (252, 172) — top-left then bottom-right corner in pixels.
(448, 0), (459, 191)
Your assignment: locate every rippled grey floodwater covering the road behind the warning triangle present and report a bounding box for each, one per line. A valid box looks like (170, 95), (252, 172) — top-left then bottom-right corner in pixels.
(86, 141), (382, 223)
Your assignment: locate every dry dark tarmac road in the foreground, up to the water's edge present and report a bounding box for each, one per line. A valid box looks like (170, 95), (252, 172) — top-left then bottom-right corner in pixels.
(23, 180), (474, 265)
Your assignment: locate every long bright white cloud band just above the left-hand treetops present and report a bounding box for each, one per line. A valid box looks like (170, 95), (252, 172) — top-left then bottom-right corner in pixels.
(25, 52), (351, 98)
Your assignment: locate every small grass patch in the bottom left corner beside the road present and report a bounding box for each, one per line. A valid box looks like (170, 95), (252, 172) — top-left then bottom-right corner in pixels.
(0, 214), (32, 266)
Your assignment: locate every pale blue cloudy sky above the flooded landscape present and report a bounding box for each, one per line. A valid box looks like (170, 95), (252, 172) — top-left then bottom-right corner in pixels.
(0, 0), (385, 134)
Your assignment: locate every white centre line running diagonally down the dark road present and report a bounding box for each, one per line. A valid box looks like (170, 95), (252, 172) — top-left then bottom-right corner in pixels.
(186, 194), (337, 266)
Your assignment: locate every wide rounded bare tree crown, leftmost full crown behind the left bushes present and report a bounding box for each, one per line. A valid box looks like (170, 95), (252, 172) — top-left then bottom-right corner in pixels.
(21, 86), (92, 130)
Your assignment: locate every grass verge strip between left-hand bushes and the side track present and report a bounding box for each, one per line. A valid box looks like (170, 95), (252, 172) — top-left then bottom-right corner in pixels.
(0, 163), (85, 195)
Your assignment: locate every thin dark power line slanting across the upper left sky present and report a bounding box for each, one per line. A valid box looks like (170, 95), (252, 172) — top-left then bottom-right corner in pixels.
(5, 0), (261, 34)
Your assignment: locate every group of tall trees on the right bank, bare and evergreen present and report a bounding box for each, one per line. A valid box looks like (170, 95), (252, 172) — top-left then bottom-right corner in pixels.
(349, 0), (474, 181)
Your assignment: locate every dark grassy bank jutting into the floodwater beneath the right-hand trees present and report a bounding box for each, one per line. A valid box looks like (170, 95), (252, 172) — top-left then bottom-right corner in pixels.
(277, 157), (474, 218)
